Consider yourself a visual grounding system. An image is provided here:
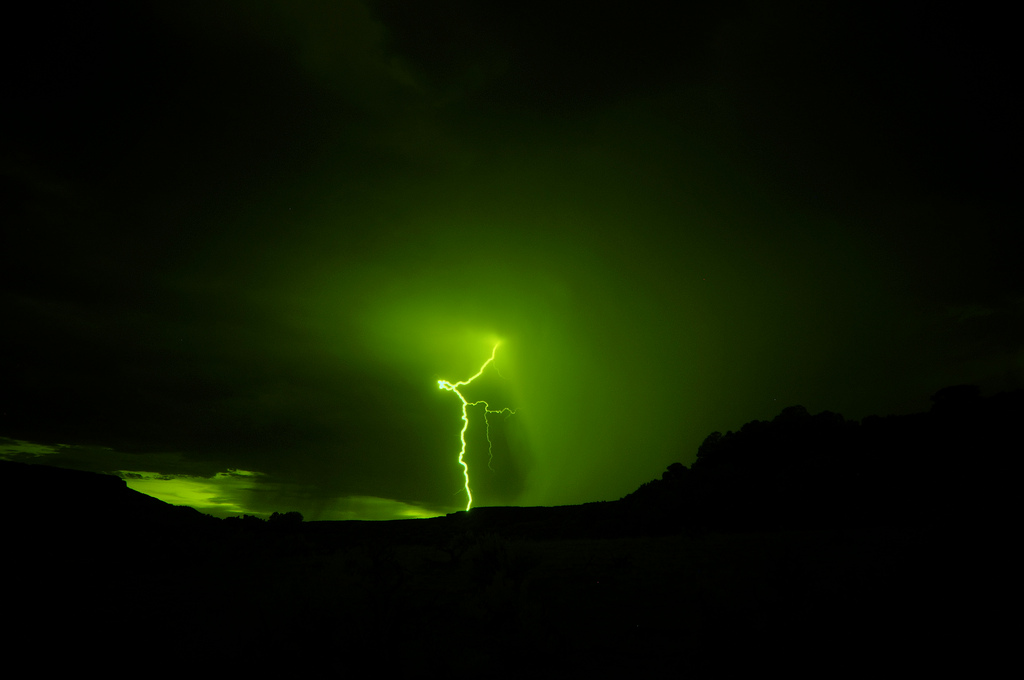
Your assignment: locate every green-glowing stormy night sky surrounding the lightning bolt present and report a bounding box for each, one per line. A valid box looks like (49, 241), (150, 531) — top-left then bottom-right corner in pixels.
(0, 0), (1024, 519)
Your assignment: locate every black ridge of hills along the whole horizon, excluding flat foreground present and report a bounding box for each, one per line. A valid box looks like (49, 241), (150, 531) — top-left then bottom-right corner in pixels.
(6, 385), (1024, 543)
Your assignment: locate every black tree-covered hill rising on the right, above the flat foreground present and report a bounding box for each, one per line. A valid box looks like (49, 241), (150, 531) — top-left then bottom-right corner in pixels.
(624, 385), (1024, 530)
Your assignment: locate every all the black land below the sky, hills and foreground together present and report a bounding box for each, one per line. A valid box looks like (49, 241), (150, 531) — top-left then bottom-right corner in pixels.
(6, 386), (1024, 677)
